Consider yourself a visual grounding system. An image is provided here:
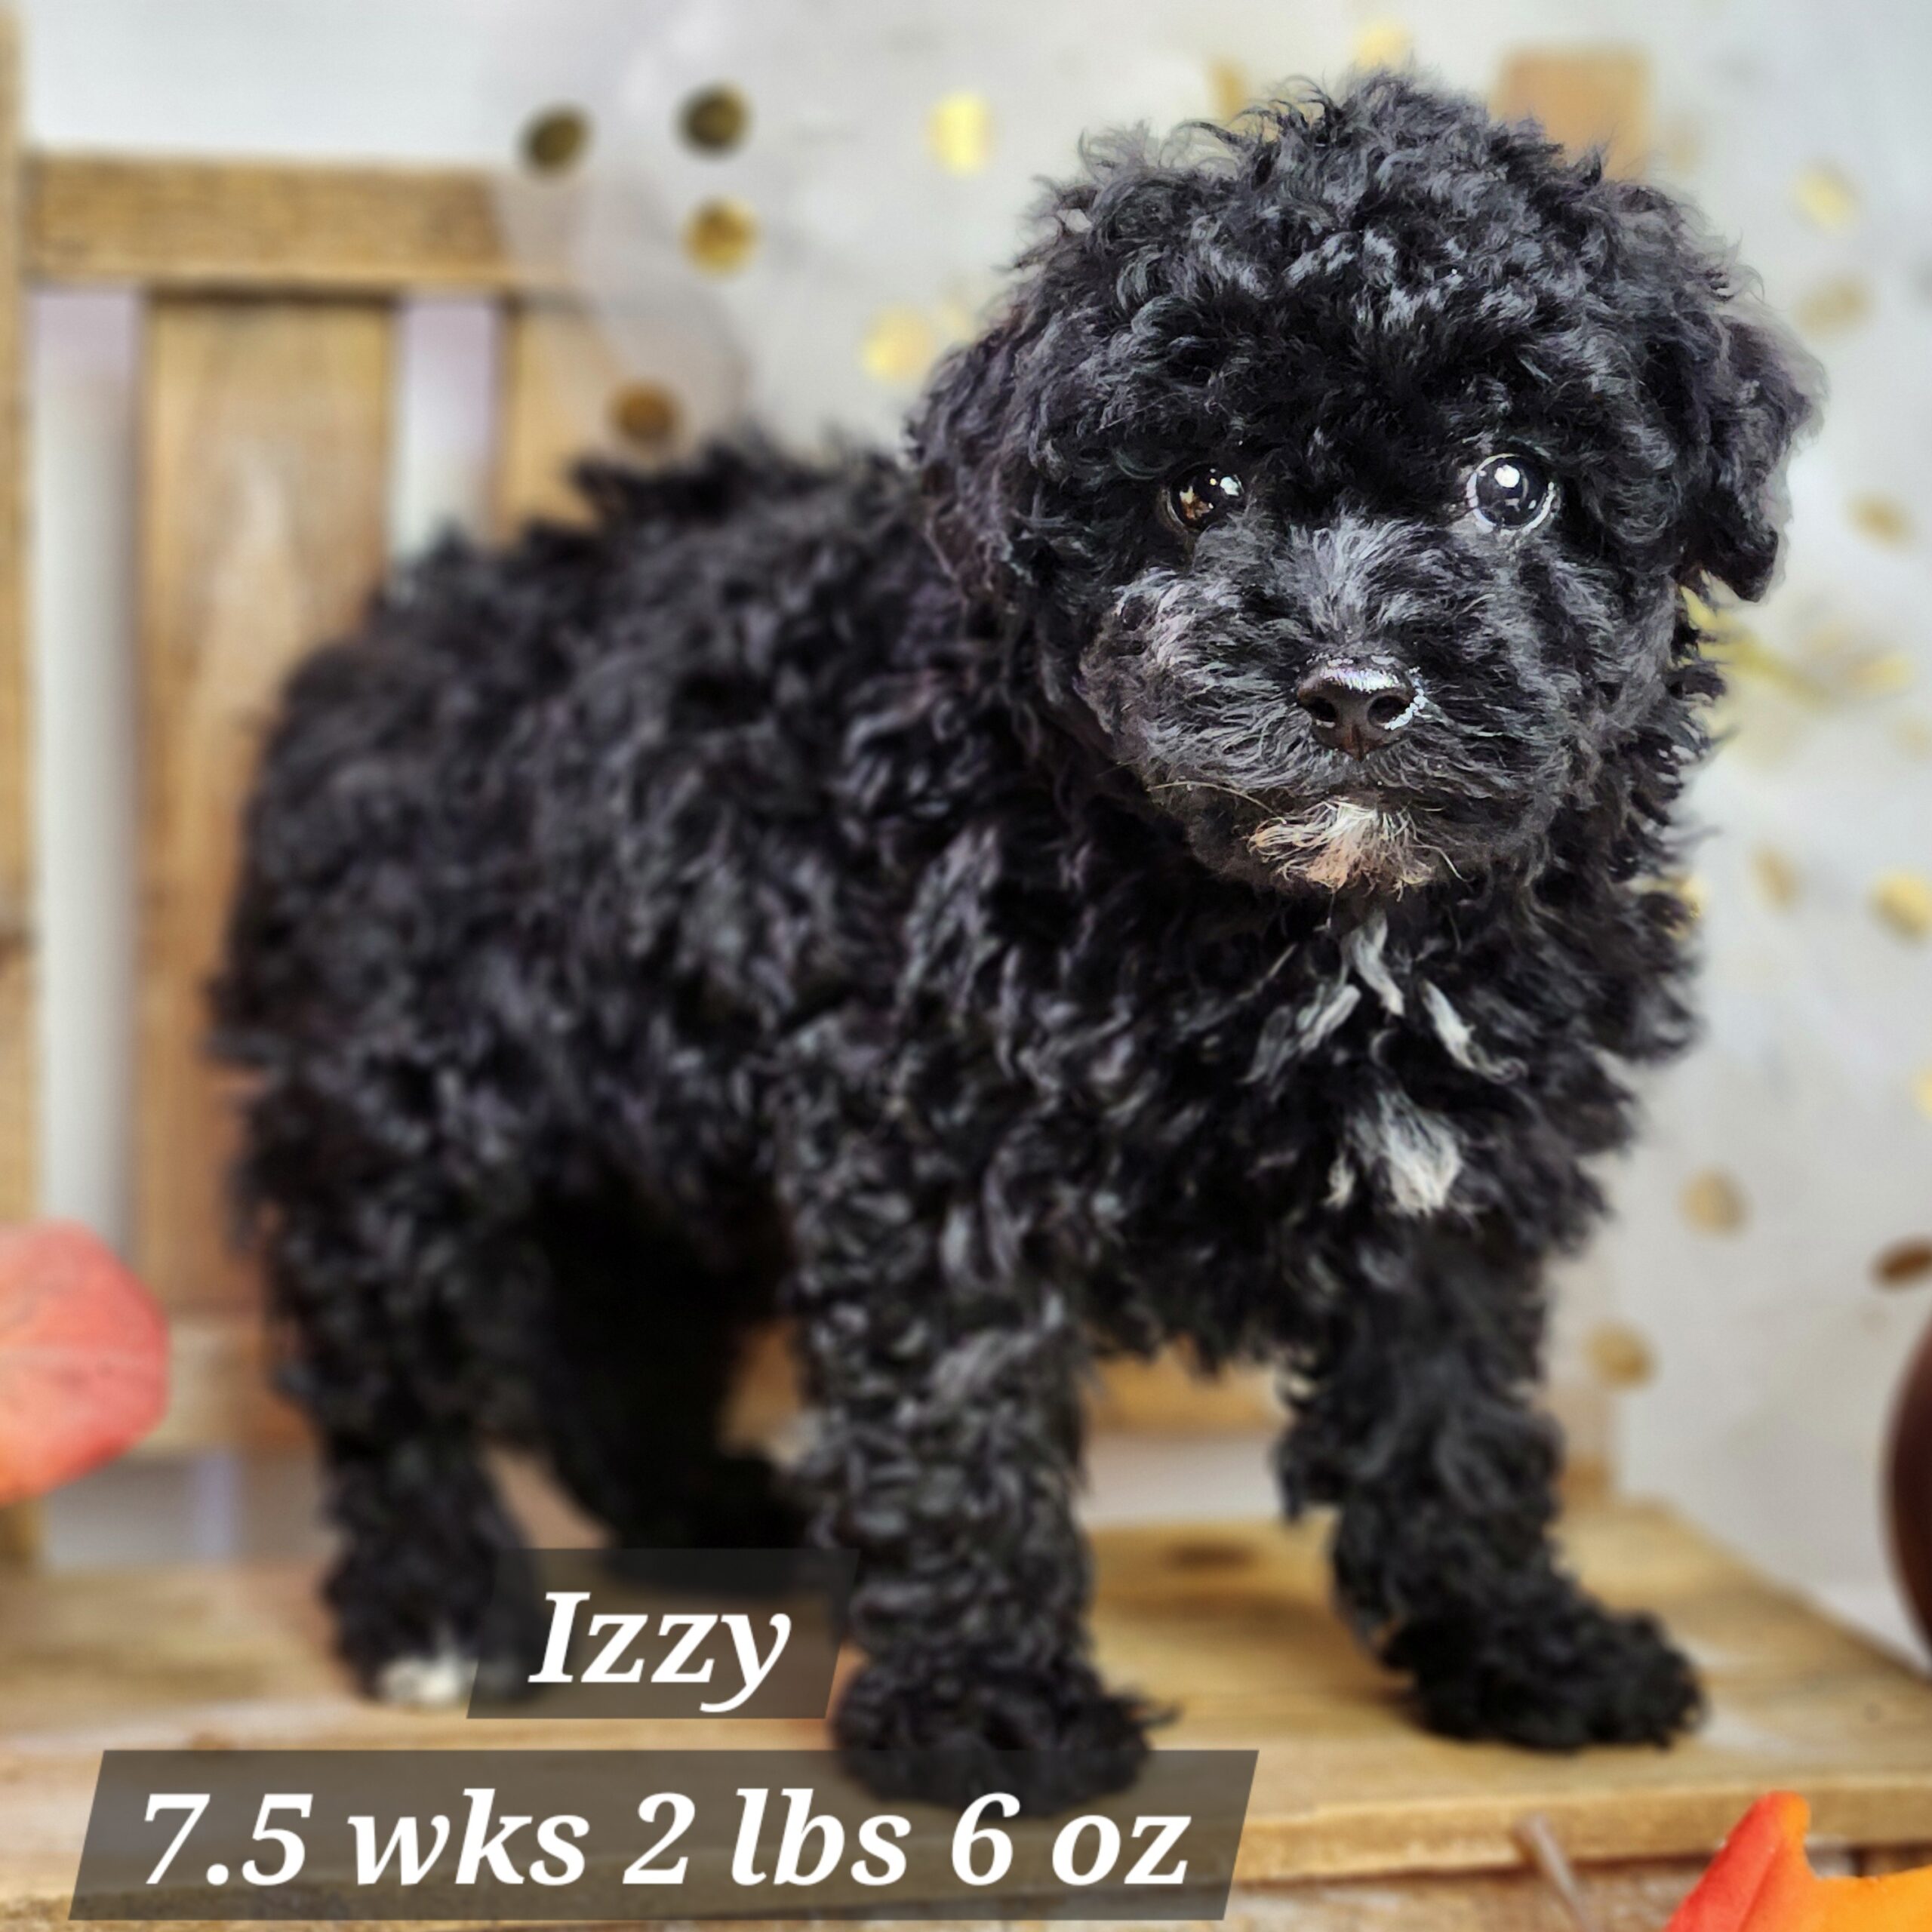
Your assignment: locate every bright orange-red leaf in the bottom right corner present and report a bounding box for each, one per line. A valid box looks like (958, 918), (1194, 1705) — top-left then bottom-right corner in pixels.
(1666, 1791), (1932, 1932)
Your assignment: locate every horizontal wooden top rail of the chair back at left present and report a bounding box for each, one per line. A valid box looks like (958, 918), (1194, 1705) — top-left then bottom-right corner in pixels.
(27, 155), (560, 296)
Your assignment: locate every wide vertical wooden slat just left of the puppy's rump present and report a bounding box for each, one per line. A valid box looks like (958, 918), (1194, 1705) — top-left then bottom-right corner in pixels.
(135, 297), (392, 1314)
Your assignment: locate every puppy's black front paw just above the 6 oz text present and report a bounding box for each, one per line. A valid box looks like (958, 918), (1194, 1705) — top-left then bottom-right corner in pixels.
(832, 1656), (1149, 1814)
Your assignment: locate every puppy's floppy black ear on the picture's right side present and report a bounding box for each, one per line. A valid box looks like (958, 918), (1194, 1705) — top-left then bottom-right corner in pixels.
(1604, 182), (1822, 597)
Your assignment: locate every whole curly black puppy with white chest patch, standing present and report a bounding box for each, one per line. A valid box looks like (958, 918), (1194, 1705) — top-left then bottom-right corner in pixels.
(220, 77), (1808, 1802)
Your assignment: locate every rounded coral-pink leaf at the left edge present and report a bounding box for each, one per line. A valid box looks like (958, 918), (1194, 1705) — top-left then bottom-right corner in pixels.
(0, 1221), (168, 1503)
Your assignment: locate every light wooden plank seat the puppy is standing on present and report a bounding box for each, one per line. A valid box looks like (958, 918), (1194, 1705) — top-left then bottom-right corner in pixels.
(0, 1505), (1932, 1932)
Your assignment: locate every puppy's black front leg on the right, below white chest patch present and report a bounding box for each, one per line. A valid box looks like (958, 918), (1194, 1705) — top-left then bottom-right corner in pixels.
(1281, 1231), (1702, 1750)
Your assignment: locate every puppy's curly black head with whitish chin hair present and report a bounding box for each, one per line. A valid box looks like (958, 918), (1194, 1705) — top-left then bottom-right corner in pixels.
(914, 77), (1808, 891)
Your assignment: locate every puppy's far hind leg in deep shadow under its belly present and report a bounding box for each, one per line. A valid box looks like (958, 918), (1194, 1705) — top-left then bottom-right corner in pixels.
(531, 1179), (801, 1549)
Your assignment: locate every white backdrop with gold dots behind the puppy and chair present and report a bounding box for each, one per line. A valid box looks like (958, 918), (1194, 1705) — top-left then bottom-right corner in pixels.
(25, 0), (1932, 1661)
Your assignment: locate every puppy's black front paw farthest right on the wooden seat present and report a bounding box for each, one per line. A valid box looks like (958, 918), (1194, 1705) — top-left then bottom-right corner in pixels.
(1386, 1590), (1704, 1750)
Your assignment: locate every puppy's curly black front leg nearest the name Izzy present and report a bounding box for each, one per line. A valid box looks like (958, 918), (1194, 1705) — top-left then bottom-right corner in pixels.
(792, 1120), (1146, 1812)
